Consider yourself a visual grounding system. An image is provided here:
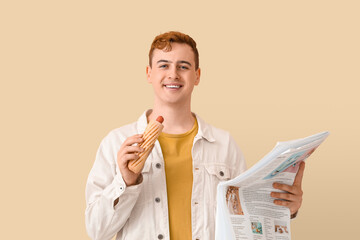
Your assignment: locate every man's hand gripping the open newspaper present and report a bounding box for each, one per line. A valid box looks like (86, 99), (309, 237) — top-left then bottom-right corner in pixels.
(271, 162), (305, 215)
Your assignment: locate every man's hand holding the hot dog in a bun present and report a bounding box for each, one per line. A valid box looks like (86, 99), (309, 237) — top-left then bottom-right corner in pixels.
(117, 134), (144, 186)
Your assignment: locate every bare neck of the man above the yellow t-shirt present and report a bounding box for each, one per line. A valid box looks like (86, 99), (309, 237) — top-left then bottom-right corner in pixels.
(148, 104), (195, 134)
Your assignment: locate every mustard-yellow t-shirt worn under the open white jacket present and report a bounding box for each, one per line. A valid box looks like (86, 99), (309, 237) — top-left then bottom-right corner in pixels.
(159, 119), (198, 240)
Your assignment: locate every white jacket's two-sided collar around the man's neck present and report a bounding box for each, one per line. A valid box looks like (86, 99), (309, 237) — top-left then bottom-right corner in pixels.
(137, 109), (215, 142)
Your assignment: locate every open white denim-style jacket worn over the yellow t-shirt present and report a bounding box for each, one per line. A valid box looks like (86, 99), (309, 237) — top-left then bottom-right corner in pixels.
(85, 109), (246, 240)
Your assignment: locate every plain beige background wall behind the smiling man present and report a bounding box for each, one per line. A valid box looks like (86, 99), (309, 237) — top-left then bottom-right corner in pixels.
(0, 0), (360, 239)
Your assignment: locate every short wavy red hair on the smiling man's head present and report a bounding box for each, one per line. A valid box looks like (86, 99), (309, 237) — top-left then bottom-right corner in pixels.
(149, 31), (199, 70)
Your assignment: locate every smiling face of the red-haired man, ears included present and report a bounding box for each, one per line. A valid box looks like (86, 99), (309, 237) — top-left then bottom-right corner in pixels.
(146, 43), (200, 104)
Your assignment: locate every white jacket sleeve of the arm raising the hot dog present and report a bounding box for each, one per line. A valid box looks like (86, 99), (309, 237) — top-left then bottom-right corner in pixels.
(85, 133), (143, 240)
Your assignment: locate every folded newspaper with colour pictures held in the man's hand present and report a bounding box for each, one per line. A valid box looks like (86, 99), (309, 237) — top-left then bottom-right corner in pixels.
(215, 132), (329, 240)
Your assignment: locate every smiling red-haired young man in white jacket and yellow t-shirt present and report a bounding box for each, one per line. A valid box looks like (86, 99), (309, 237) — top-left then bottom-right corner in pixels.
(86, 32), (304, 240)
